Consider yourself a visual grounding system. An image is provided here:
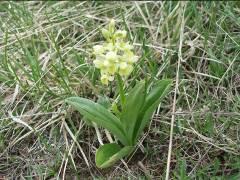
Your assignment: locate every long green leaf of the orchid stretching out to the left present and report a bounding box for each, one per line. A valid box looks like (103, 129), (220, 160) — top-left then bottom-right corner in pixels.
(66, 97), (129, 145)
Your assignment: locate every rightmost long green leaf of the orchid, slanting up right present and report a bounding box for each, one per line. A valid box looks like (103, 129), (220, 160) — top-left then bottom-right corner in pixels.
(132, 79), (172, 143)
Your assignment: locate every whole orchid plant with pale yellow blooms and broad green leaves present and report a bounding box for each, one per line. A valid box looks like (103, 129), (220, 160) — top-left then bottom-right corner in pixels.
(66, 20), (172, 168)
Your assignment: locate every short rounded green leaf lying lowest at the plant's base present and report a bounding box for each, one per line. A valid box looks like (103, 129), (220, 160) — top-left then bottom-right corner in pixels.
(95, 143), (134, 168)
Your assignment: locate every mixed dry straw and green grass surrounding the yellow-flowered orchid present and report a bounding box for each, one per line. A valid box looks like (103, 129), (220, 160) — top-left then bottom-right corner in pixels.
(0, 1), (240, 179)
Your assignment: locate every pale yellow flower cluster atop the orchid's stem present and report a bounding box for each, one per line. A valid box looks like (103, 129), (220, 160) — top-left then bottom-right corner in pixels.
(93, 20), (138, 85)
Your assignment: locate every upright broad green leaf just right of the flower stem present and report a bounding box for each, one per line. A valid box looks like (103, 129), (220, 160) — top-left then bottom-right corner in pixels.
(120, 82), (145, 145)
